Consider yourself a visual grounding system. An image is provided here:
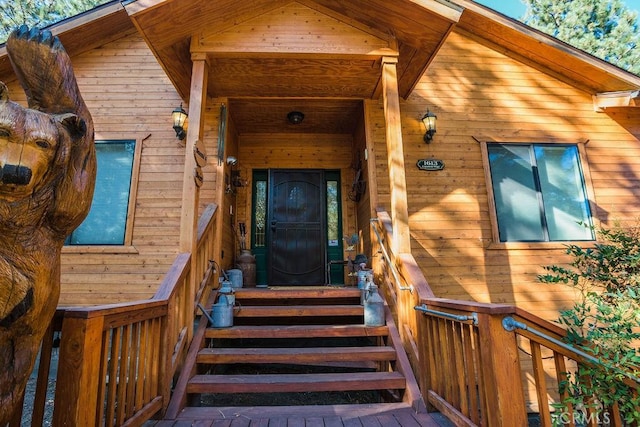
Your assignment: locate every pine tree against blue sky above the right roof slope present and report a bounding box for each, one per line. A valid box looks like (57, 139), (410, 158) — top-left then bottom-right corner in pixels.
(523, 0), (640, 75)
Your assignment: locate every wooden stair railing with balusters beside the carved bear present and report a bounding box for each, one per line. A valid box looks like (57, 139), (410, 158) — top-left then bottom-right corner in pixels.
(11, 205), (216, 426)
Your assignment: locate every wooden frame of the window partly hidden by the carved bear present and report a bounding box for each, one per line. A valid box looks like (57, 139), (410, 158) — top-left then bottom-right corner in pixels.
(62, 136), (146, 254)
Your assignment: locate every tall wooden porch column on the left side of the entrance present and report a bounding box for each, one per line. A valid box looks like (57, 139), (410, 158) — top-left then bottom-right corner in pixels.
(180, 54), (209, 328)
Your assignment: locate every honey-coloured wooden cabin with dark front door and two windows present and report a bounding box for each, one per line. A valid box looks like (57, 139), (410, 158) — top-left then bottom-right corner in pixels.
(0, 0), (640, 425)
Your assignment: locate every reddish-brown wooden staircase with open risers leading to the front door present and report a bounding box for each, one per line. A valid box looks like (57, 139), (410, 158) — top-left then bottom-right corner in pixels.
(165, 286), (425, 419)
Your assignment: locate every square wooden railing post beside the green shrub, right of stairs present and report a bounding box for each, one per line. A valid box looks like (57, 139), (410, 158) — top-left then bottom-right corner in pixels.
(478, 313), (527, 427)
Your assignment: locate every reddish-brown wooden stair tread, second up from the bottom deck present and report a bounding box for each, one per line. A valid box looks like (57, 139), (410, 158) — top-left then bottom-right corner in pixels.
(198, 346), (396, 364)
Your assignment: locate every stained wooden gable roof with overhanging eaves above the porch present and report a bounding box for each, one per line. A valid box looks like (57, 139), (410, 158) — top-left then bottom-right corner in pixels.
(0, 0), (640, 103)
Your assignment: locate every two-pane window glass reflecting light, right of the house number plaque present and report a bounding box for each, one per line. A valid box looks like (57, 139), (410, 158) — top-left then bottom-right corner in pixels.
(487, 144), (594, 242)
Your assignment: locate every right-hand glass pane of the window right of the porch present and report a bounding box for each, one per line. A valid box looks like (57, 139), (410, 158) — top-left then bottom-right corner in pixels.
(534, 145), (593, 241)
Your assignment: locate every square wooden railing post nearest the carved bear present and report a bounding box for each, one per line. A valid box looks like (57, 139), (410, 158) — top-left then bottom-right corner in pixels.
(53, 312), (104, 426)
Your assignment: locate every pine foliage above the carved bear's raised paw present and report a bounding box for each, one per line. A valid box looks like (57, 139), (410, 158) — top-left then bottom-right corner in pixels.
(0, 0), (107, 43)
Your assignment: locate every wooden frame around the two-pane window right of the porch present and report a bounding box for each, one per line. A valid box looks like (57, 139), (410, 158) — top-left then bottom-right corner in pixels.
(482, 138), (598, 249)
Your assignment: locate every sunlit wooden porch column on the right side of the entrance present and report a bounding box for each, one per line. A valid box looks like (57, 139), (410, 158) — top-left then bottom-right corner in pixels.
(382, 57), (411, 254)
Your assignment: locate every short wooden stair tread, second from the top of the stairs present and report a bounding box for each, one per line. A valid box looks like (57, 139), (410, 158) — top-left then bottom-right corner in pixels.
(234, 304), (364, 317)
